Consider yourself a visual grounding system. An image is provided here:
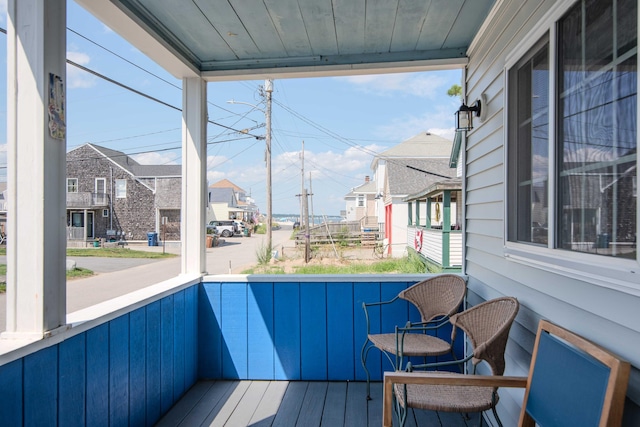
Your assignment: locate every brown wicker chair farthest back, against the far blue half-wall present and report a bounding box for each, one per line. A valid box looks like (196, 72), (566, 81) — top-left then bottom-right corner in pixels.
(360, 274), (467, 399)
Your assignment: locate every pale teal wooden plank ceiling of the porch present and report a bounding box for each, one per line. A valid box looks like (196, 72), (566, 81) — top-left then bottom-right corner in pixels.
(85, 0), (495, 77)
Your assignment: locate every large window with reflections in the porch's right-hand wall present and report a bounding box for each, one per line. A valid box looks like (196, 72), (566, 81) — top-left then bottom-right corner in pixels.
(507, 0), (638, 260)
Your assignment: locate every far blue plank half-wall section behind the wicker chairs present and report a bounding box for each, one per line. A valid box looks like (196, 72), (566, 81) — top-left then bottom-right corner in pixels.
(198, 281), (463, 381)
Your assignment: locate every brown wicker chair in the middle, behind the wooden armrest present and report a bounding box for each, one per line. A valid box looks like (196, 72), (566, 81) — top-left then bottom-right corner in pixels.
(394, 297), (519, 426)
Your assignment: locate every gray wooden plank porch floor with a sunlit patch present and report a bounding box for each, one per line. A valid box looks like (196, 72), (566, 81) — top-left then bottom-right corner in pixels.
(157, 381), (478, 427)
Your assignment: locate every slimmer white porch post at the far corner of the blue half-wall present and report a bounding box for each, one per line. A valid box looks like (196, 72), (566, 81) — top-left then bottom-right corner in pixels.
(180, 77), (207, 274)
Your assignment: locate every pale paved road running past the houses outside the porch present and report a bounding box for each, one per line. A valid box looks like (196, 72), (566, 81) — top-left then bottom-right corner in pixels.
(0, 225), (294, 331)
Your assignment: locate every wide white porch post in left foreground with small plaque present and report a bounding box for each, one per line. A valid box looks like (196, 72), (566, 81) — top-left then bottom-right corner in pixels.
(2, 0), (66, 338)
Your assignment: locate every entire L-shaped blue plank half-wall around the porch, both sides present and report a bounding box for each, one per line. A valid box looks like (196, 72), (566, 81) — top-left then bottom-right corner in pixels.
(0, 276), (461, 426)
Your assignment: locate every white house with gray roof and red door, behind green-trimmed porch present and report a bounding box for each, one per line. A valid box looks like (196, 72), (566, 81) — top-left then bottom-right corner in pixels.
(371, 132), (456, 257)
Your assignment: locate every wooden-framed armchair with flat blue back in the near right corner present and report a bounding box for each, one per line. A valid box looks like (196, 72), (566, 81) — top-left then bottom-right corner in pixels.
(382, 320), (631, 427)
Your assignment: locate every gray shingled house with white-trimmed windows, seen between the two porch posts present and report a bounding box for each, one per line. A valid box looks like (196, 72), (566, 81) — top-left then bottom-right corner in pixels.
(66, 144), (182, 244)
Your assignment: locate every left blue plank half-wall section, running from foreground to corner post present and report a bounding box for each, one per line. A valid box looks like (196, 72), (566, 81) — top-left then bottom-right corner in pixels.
(0, 286), (198, 426)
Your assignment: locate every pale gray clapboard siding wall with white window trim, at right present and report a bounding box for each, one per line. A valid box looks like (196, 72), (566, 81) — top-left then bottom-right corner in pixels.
(464, 0), (640, 425)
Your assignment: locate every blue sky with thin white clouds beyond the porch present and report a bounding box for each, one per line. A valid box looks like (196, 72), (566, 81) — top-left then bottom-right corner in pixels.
(0, 0), (462, 215)
